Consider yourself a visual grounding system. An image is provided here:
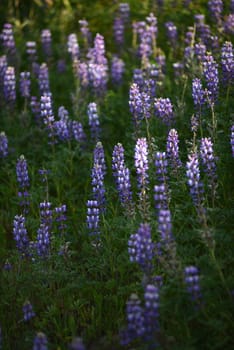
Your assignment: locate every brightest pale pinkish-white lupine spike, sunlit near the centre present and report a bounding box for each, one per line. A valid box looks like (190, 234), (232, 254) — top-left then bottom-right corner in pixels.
(134, 137), (149, 199)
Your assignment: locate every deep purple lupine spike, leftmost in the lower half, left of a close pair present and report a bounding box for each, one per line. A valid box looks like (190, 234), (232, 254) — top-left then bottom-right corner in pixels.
(13, 215), (29, 255)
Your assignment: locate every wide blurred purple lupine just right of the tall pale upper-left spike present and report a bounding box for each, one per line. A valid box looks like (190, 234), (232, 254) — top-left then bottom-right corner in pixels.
(54, 106), (71, 141)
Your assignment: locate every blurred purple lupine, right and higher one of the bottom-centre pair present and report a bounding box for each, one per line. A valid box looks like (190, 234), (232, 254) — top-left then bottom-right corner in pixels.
(144, 284), (159, 340)
